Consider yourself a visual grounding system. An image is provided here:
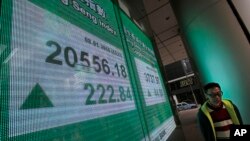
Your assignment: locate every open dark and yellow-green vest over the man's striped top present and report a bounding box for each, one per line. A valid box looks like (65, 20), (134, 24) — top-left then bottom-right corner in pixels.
(197, 100), (243, 141)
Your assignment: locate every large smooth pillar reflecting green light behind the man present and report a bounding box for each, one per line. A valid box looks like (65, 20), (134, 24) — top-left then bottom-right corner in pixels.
(171, 0), (250, 124)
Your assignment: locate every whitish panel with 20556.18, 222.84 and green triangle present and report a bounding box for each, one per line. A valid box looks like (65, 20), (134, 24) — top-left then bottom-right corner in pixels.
(9, 1), (135, 136)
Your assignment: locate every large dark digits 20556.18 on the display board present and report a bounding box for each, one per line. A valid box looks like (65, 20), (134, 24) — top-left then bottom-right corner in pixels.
(45, 40), (127, 78)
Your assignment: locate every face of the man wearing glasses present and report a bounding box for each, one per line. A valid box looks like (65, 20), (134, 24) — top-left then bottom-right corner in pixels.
(207, 87), (222, 106)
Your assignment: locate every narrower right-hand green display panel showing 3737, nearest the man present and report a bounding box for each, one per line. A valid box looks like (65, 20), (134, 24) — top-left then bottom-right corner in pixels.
(120, 12), (176, 141)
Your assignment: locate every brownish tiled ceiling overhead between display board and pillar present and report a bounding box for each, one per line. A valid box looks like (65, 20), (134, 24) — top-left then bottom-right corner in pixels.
(121, 0), (187, 65)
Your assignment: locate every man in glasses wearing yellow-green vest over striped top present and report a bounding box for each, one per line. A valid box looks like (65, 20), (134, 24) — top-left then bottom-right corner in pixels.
(197, 82), (242, 141)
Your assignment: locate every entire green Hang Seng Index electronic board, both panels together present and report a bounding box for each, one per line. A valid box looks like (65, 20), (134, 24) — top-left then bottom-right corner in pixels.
(0, 0), (175, 141)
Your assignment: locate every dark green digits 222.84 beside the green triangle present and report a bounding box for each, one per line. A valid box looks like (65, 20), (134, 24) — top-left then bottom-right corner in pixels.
(84, 83), (133, 105)
